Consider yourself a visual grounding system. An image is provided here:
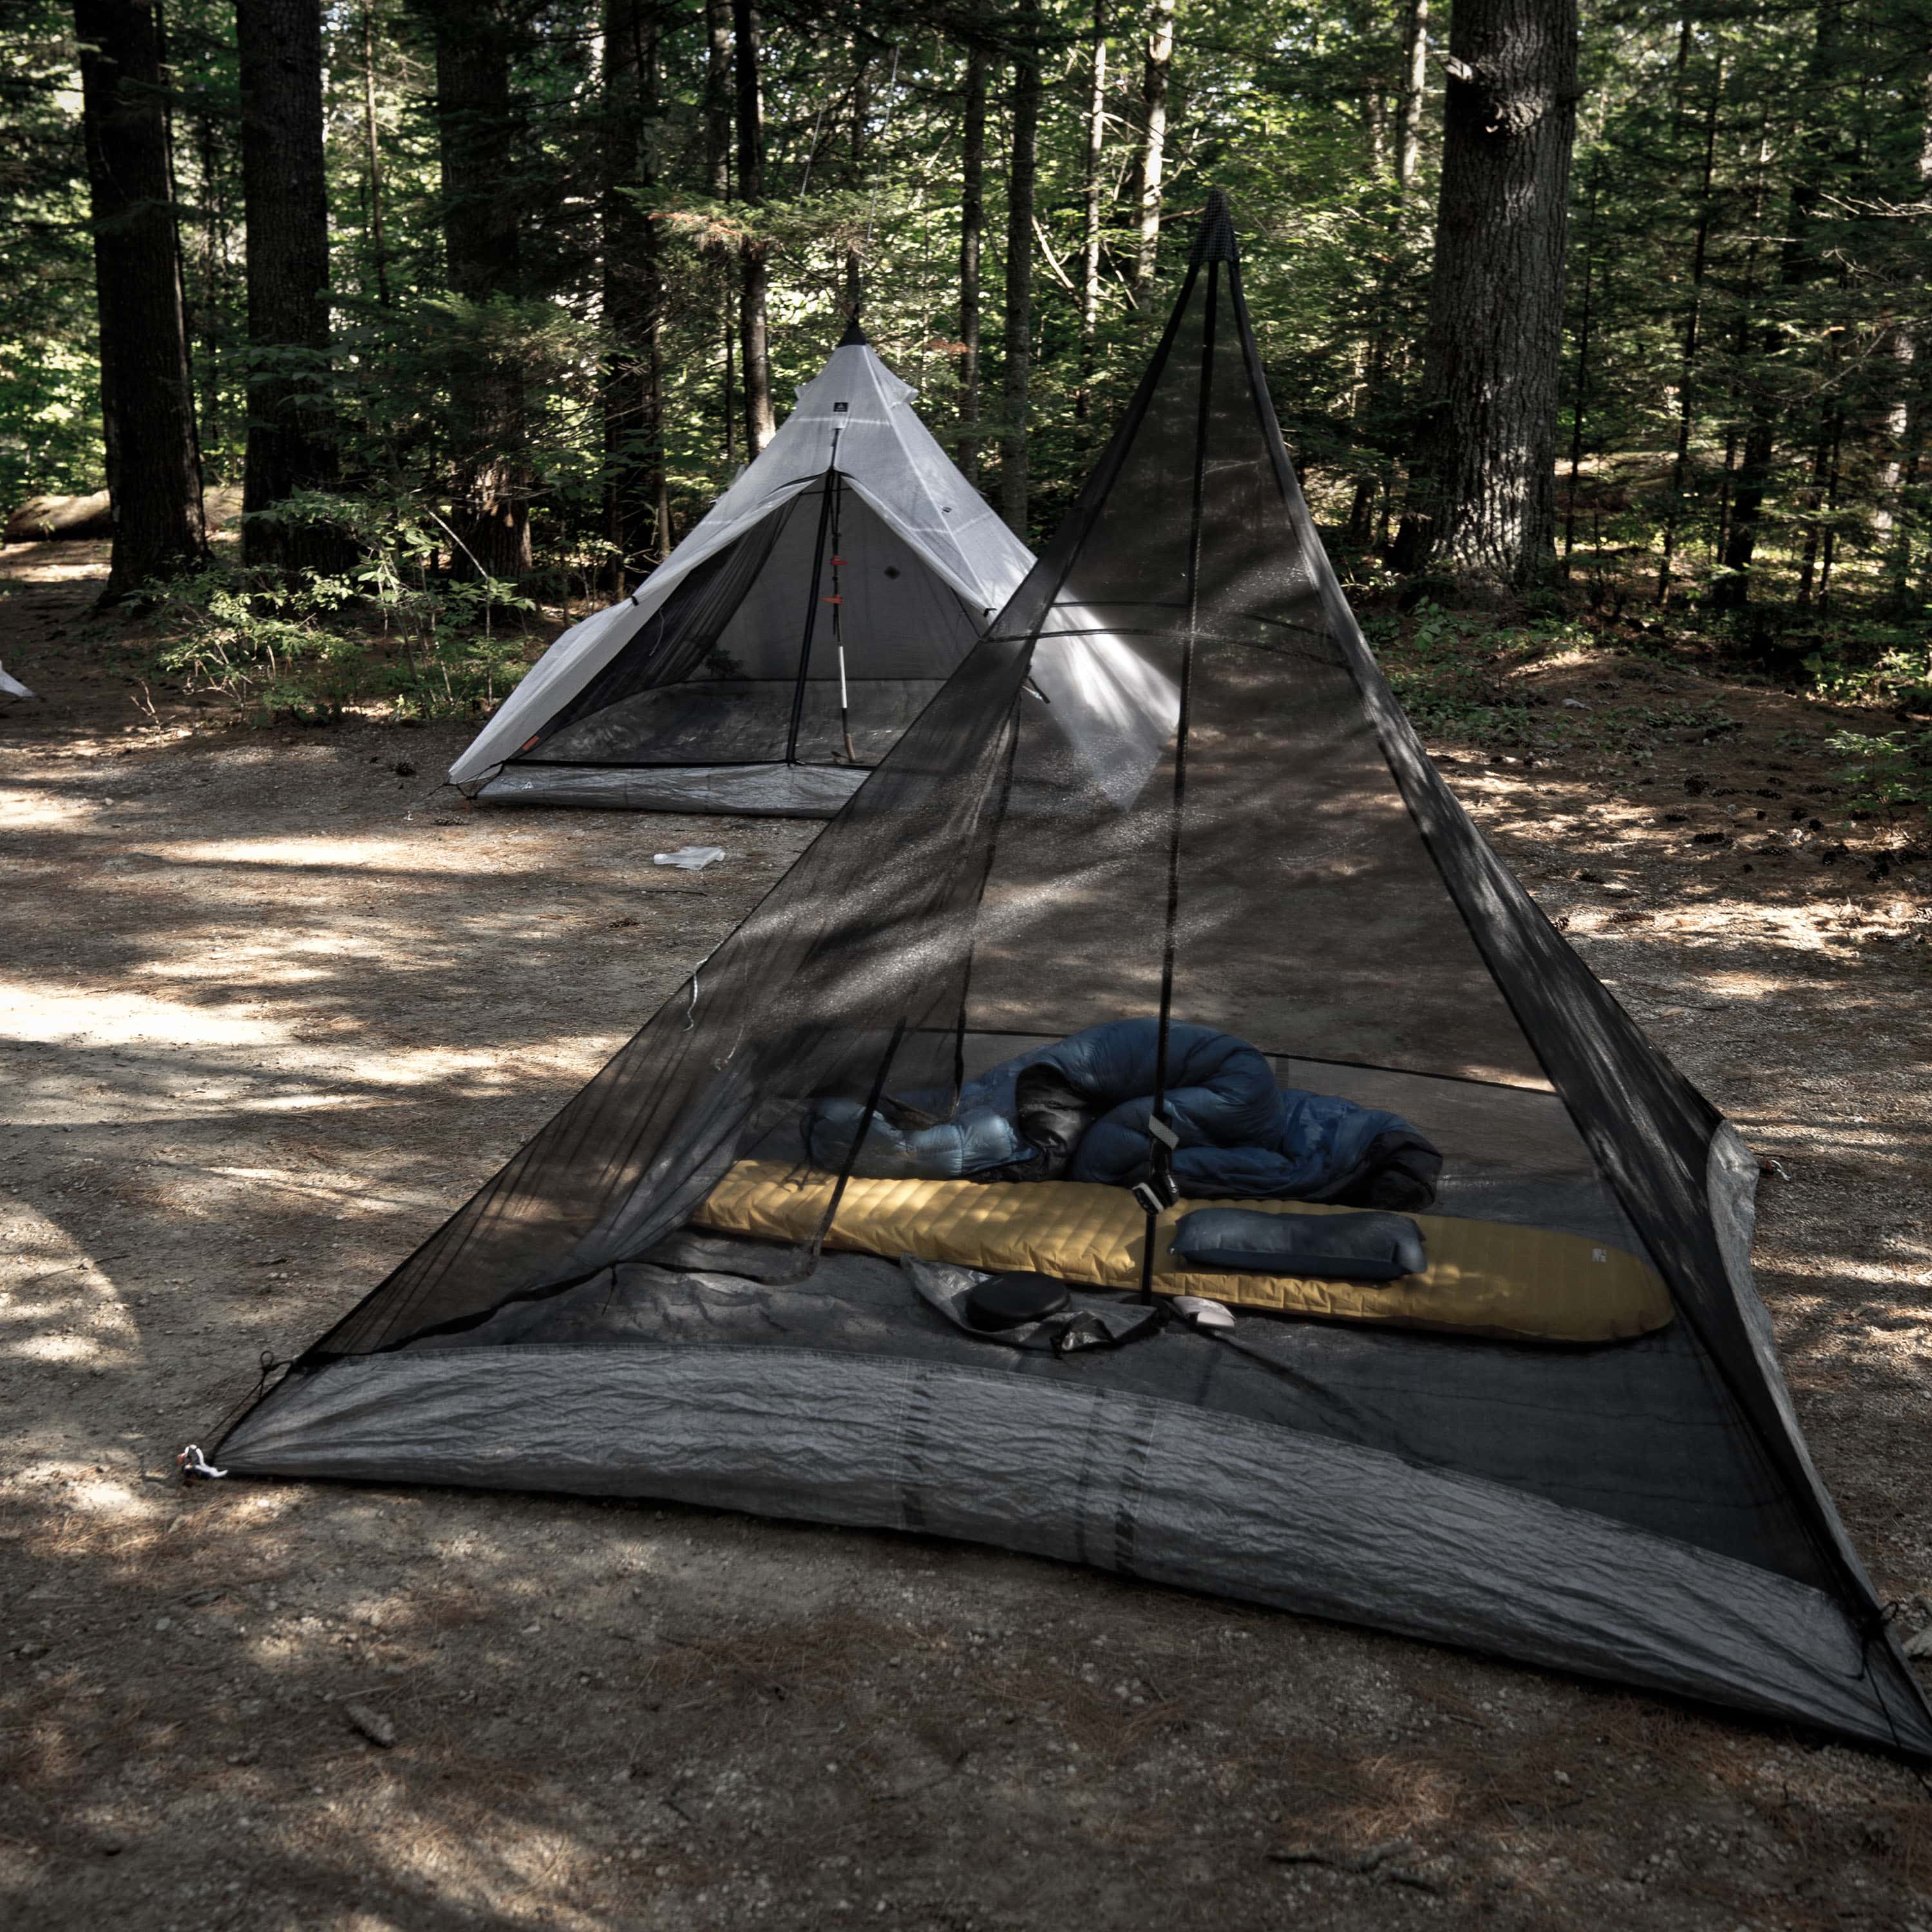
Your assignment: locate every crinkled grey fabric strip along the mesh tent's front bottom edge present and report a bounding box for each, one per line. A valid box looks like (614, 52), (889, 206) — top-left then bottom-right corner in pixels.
(222, 1329), (1932, 1750)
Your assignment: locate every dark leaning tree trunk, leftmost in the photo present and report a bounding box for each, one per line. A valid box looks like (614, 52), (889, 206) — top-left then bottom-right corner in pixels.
(73, 0), (209, 603)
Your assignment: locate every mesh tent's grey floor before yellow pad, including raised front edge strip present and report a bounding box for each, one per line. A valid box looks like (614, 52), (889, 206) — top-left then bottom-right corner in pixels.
(222, 1235), (1917, 1743)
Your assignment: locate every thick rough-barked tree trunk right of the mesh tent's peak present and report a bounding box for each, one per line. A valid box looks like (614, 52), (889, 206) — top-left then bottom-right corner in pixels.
(1401, 0), (1577, 587)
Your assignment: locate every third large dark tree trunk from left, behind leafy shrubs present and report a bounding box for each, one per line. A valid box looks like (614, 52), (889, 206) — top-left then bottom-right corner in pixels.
(435, 0), (531, 580)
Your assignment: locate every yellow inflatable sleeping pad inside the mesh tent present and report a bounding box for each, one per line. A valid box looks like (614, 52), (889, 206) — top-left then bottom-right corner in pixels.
(694, 1161), (1671, 1343)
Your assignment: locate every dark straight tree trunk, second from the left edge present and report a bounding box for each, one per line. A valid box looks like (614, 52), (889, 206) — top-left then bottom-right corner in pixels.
(236, 0), (348, 570)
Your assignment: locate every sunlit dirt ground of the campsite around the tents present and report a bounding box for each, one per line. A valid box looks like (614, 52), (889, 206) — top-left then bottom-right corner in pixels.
(0, 545), (1932, 1932)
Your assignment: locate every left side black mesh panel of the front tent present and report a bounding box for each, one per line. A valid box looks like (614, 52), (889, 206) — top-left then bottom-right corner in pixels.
(311, 643), (1026, 1356)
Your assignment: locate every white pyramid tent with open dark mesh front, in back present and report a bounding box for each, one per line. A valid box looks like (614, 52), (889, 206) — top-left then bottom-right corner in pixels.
(450, 323), (1034, 817)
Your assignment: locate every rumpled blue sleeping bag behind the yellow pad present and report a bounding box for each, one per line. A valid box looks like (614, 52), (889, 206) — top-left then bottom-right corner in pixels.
(808, 1020), (1441, 1211)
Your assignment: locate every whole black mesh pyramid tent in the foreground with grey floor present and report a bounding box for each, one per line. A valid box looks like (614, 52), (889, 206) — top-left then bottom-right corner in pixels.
(218, 199), (1932, 1756)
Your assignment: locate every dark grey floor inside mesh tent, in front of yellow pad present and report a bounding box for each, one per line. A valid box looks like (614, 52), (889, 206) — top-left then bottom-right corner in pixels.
(396, 1235), (1816, 1580)
